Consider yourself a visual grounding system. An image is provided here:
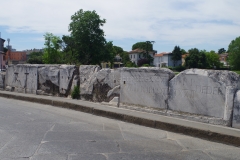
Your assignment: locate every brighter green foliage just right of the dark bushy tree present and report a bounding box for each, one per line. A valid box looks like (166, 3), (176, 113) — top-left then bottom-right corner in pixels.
(205, 51), (222, 68)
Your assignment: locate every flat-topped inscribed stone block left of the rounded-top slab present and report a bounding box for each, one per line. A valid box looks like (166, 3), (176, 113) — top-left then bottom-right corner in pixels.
(120, 68), (174, 109)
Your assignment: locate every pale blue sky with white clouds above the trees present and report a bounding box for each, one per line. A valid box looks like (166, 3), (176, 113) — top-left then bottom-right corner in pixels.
(0, 0), (240, 53)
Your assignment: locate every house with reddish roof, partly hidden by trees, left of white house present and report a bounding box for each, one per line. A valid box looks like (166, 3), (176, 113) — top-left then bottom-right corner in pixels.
(128, 48), (157, 65)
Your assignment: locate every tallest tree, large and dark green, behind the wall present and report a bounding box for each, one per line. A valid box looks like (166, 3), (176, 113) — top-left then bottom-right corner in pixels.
(69, 9), (111, 65)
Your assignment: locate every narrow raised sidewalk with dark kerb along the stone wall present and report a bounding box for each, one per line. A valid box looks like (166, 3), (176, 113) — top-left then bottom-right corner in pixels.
(0, 91), (240, 146)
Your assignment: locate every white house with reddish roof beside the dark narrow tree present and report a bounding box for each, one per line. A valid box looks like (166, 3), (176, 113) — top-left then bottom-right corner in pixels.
(153, 52), (182, 68)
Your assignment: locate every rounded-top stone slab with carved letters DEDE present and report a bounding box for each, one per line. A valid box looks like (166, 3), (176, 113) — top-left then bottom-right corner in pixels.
(168, 69), (240, 121)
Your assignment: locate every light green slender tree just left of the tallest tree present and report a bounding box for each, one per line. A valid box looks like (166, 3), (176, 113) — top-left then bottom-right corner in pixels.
(43, 33), (62, 64)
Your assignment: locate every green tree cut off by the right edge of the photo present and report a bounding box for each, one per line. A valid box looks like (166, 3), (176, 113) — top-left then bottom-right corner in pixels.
(228, 36), (240, 70)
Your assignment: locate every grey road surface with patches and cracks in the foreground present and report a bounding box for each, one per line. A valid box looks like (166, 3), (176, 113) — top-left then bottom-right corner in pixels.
(0, 98), (240, 160)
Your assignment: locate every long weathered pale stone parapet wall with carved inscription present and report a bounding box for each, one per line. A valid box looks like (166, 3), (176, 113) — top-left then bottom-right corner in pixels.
(0, 64), (240, 128)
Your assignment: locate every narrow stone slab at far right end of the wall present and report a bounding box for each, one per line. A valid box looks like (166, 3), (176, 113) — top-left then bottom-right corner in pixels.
(232, 90), (240, 129)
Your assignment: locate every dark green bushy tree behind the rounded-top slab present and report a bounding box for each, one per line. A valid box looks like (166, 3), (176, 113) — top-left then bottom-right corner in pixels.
(185, 48), (206, 68)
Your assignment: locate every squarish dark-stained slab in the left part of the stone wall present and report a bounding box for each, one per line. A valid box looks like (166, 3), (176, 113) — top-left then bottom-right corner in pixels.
(38, 65), (60, 95)
